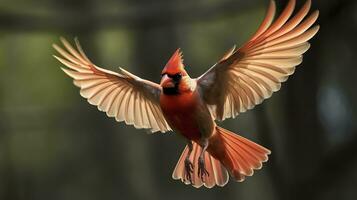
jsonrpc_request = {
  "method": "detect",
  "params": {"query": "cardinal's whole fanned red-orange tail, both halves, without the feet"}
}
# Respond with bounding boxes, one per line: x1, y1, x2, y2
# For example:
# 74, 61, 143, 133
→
172, 126, 270, 188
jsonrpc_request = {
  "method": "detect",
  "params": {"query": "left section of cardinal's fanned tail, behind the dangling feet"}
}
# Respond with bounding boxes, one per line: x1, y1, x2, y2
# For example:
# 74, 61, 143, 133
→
172, 142, 229, 188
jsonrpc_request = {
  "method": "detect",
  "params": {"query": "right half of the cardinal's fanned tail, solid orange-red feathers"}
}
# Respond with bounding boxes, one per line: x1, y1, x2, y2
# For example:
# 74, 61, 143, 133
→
217, 127, 270, 182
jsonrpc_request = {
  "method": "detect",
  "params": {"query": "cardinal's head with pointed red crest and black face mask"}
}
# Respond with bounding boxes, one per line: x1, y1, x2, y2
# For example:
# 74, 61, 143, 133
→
160, 49, 187, 94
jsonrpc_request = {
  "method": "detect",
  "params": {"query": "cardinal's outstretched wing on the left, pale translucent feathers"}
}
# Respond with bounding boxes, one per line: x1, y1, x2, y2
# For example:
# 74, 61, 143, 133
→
53, 38, 171, 132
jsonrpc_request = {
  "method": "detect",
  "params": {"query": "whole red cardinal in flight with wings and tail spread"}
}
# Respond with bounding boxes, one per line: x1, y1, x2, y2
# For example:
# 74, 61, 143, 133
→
53, 0, 319, 188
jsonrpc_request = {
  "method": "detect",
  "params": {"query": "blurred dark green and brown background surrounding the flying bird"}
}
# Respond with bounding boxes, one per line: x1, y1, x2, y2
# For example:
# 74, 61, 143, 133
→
0, 0, 357, 200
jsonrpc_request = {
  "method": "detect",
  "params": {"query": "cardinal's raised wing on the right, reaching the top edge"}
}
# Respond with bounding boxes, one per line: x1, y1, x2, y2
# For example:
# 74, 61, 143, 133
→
197, 0, 319, 120
